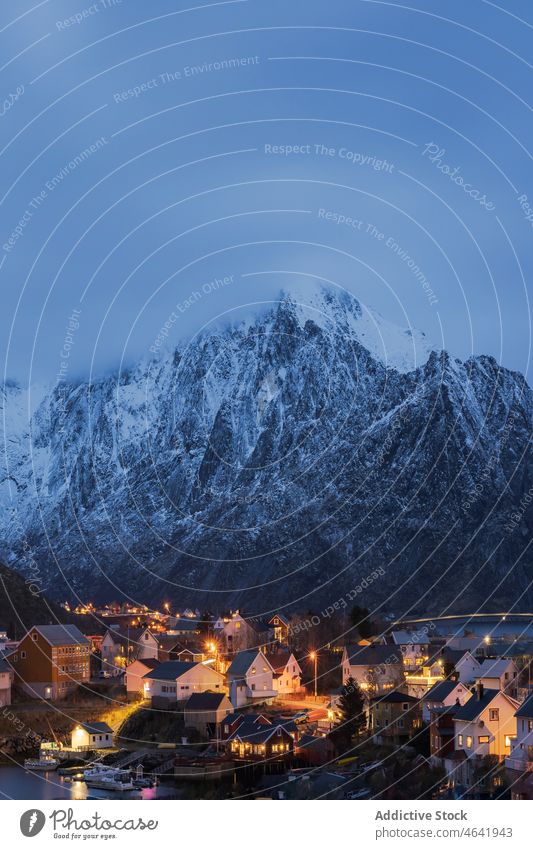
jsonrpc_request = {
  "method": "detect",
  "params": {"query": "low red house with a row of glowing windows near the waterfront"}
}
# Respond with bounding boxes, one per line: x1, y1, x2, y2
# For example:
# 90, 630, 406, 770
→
225, 714, 294, 762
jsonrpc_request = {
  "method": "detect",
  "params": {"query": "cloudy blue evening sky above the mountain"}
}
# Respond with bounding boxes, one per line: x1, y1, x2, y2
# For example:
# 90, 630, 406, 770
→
0, 0, 533, 384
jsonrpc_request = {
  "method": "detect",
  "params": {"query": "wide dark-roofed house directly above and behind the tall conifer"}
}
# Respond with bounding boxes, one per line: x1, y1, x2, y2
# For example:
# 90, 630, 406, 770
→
342, 644, 404, 696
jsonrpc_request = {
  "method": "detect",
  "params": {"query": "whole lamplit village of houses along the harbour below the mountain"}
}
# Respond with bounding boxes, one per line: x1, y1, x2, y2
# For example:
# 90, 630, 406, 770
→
0, 603, 533, 800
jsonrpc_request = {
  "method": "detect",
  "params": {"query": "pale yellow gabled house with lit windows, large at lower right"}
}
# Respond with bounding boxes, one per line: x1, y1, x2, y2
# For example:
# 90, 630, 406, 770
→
444, 682, 519, 785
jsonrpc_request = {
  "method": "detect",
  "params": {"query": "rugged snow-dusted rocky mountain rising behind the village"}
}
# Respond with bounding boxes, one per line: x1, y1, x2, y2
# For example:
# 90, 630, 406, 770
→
0, 288, 533, 613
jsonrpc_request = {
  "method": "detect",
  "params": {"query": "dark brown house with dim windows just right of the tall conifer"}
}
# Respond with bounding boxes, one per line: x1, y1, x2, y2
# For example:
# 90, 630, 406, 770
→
368, 691, 422, 746
